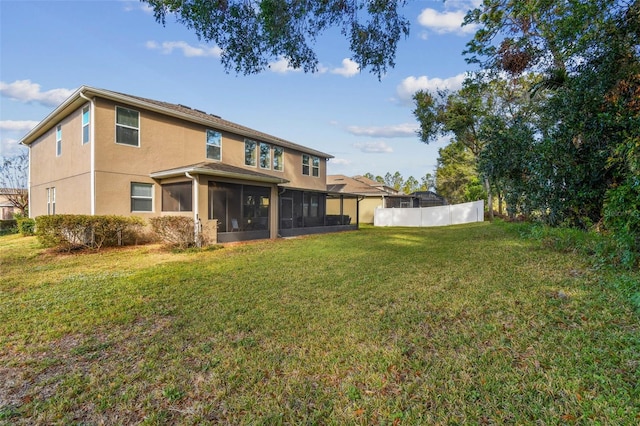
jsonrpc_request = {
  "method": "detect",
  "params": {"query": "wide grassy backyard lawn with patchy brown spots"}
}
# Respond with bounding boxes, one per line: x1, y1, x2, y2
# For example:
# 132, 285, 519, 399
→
0, 223, 640, 425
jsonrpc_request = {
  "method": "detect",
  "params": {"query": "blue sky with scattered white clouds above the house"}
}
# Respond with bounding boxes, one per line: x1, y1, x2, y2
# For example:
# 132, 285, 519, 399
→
0, 0, 478, 180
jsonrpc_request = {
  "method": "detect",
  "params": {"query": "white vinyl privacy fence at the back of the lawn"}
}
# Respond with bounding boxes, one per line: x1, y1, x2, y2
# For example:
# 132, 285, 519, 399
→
373, 200, 484, 226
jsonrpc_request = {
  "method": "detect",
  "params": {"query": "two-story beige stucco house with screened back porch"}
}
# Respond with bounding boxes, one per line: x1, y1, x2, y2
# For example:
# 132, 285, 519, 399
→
21, 86, 357, 242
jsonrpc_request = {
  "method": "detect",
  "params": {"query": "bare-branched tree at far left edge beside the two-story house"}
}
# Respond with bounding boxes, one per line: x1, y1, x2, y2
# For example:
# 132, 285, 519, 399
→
0, 152, 29, 215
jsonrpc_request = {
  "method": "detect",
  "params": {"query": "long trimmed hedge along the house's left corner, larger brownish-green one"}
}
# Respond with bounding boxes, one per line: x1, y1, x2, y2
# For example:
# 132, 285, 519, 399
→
36, 215, 144, 251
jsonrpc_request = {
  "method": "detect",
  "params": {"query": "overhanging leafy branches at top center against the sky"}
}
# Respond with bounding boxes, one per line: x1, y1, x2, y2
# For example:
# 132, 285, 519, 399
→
142, 0, 409, 78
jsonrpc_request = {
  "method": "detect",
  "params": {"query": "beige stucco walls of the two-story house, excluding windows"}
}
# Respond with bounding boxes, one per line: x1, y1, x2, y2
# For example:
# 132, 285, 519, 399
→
30, 95, 327, 243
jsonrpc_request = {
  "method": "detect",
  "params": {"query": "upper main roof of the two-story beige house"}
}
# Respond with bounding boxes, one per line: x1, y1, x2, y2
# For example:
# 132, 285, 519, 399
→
20, 86, 333, 158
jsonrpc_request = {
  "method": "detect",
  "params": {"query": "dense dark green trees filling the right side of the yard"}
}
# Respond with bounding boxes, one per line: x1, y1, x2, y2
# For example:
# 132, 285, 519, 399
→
414, 0, 640, 267
